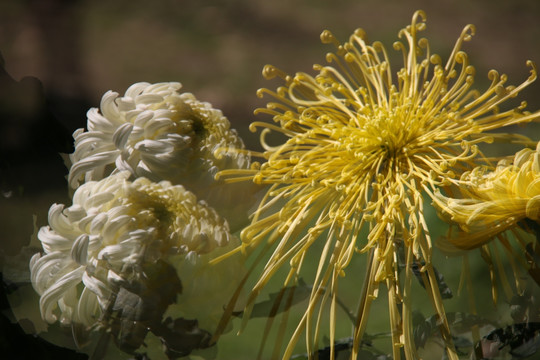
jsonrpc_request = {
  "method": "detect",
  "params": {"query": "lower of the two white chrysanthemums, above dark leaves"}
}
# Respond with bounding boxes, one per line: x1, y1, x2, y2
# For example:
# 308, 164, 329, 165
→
30, 172, 242, 332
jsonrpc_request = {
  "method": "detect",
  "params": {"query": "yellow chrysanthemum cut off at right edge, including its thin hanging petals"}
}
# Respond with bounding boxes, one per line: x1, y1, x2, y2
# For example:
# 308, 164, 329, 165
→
435, 143, 540, 301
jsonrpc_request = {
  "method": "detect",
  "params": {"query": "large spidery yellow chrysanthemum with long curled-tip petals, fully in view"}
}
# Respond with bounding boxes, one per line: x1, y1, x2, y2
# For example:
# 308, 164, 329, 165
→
216, 11, 539, 359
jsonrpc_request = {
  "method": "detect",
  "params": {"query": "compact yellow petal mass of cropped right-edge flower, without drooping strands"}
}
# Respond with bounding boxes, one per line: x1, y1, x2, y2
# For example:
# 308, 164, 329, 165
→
436, 142, 540, 249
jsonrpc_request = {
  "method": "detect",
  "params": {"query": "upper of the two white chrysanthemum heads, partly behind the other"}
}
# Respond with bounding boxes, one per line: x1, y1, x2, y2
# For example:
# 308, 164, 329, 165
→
69, 82, 250, 228
